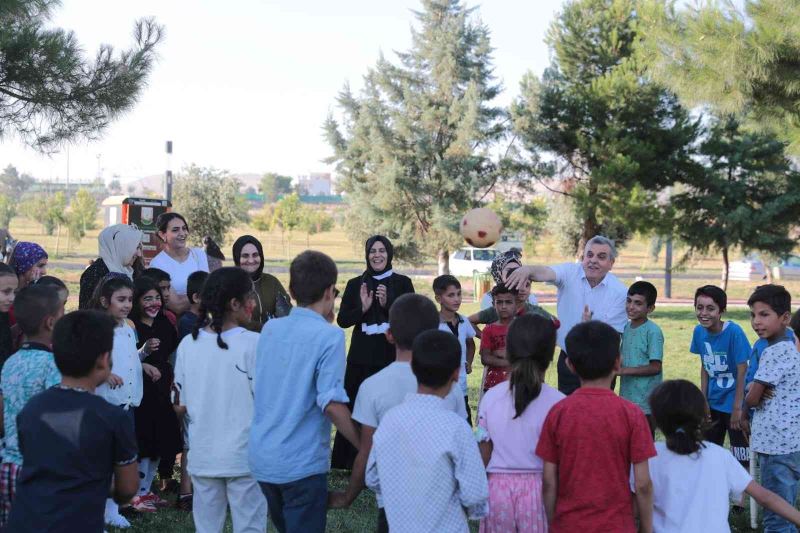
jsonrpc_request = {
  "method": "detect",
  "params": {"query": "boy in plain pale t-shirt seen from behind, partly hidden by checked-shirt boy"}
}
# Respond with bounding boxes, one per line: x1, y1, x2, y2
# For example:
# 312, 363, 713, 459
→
328, 294, 468, 533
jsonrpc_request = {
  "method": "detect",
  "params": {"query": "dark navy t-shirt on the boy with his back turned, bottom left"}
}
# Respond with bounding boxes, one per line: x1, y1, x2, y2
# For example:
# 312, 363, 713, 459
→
8, 387, 136, 533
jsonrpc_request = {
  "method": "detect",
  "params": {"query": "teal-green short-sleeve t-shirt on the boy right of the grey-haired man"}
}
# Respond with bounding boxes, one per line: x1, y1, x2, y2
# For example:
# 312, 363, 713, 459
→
619, 320, 664, 414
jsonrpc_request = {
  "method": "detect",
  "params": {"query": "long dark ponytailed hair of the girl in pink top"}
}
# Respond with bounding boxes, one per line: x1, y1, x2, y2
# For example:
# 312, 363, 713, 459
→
506, 315, 556, 418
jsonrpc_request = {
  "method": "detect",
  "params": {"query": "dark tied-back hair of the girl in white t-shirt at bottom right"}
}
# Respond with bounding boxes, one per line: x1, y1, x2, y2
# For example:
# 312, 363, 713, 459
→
650, 379, 708, 455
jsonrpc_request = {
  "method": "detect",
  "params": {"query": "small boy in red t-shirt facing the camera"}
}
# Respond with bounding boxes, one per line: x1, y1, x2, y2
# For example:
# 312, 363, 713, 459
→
480, 285, 519, 392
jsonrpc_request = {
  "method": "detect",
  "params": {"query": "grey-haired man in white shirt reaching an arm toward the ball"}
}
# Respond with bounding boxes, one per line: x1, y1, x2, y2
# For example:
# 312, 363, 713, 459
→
506, 235, 628, 394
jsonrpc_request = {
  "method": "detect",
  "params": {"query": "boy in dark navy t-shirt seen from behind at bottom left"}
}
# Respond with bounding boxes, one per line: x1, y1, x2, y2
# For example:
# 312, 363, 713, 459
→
7, 311, 139, 533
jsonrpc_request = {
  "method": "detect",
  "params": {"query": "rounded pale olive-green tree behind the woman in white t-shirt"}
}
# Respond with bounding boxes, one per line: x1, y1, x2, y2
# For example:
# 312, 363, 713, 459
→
173, 165, 248, 245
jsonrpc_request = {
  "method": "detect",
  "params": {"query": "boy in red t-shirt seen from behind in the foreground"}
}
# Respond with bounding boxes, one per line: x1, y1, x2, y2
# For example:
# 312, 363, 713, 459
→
536, 321, 656, 533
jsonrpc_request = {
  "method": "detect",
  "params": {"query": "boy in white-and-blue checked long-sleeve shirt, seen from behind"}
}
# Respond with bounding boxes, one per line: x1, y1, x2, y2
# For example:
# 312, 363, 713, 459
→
366, 330, 489, 533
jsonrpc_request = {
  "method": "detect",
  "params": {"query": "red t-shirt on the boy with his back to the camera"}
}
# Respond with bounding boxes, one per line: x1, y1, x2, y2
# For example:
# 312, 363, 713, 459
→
536, 387, 656, 533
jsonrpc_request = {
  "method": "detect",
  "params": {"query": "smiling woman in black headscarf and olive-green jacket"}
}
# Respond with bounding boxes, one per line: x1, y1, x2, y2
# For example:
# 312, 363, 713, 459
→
233, 235, 292, 332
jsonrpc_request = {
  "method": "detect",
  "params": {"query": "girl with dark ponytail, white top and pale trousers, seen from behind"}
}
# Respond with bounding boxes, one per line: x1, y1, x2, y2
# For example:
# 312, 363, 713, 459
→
175, 267, 267, 531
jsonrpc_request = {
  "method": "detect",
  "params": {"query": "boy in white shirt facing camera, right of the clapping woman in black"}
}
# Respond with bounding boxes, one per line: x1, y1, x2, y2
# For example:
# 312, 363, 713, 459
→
433, 274, 475, 426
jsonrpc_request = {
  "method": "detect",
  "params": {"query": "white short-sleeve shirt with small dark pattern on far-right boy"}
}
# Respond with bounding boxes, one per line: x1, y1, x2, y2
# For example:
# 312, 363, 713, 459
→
750, 340, 800, 455
